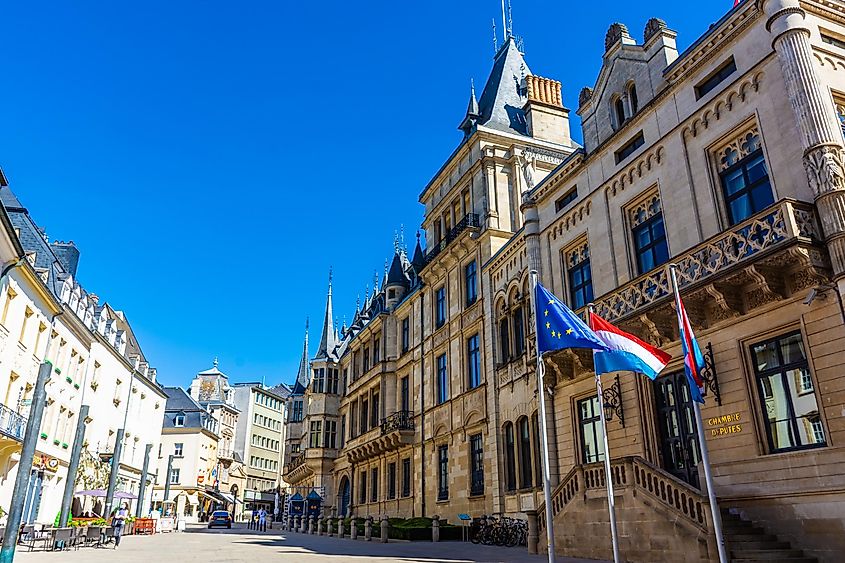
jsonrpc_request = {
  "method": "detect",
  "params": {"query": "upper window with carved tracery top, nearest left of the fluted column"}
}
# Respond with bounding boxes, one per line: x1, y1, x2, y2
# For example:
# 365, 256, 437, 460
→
719, 131, 774, 225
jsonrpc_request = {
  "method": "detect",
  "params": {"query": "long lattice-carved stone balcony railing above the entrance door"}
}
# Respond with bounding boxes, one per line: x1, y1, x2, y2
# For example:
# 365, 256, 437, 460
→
595, 200, 822, 321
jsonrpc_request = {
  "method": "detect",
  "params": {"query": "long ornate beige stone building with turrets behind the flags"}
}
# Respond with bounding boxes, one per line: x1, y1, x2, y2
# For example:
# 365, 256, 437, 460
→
286, 0, 845, 561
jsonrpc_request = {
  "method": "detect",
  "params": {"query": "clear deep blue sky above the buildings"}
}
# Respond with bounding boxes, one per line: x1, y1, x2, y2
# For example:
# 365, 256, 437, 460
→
0, 0, 733, 385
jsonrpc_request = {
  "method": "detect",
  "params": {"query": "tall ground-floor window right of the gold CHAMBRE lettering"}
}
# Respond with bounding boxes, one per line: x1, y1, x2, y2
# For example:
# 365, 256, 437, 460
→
751, 332, 827, 453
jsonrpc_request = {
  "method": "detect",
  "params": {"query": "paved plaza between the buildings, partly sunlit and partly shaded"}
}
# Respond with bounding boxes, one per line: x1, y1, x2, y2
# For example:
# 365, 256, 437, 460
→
15, 526, 608, 563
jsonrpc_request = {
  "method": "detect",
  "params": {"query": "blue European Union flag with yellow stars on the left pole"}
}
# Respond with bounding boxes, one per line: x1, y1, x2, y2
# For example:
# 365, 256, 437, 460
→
534, 283, 607, 354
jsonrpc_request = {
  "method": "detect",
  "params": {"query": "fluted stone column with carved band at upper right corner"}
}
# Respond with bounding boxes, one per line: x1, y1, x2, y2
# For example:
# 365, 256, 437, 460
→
757, 0, 845, 279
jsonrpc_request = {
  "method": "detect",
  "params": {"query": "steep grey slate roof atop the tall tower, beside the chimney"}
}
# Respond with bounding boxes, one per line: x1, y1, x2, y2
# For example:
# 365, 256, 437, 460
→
470, 37, 531, 135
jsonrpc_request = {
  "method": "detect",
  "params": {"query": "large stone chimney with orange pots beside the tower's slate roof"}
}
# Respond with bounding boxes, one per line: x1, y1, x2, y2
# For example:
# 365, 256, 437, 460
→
523, 74, 572, 146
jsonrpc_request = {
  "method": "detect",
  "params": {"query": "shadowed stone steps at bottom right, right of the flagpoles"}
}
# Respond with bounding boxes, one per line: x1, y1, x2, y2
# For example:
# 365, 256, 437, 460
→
721, 508, 818, 563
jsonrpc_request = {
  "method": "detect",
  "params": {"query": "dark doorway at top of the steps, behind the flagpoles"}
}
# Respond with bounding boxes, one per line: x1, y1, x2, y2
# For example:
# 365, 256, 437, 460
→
654, 371, 701, 489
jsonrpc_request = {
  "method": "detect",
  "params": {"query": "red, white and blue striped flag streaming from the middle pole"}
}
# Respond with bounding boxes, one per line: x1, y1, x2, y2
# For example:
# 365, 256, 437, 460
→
590, 313, 672, 379
